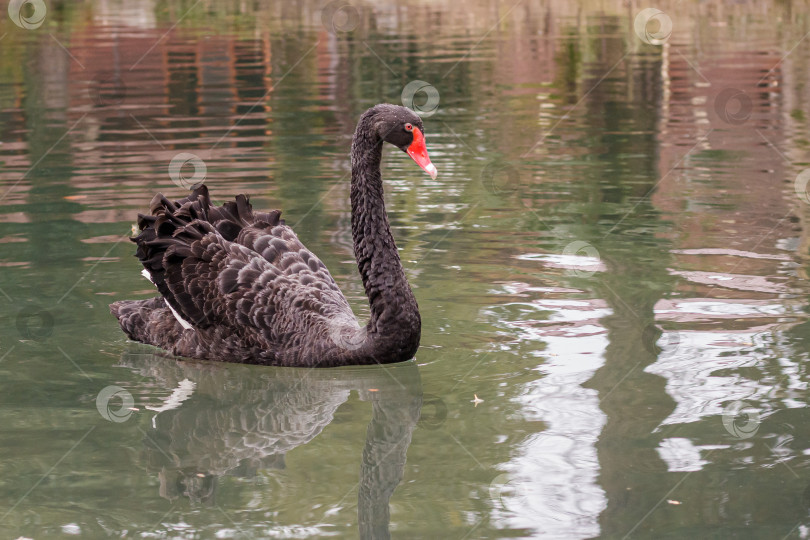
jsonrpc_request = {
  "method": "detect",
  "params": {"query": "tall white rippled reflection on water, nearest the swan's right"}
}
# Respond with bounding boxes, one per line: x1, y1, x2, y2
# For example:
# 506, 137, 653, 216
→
486, 292, 610, 538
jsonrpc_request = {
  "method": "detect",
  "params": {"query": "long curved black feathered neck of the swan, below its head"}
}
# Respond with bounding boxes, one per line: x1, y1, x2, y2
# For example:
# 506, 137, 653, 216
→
351, 120, 421, 354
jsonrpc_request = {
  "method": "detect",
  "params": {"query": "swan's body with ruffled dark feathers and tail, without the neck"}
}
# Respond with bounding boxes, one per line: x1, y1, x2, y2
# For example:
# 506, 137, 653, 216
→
111, 186, 359, 366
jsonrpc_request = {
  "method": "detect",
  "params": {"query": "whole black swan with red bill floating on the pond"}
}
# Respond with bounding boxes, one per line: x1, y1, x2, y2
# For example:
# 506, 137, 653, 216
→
110, 104, 437, 367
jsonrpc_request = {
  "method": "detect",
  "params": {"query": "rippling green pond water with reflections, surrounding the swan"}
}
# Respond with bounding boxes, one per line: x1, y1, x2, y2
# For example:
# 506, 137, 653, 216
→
0, 0, 810, 539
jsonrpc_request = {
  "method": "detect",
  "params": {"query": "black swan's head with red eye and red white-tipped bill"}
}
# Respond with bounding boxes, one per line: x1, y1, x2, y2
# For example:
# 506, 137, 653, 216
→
368, 104, 439, 179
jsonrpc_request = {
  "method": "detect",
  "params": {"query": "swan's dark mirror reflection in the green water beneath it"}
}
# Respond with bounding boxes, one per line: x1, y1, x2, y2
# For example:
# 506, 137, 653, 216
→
121, 351, 422, 539
